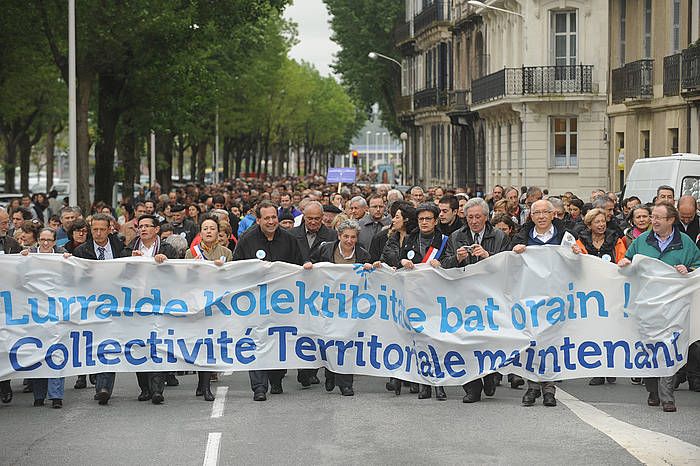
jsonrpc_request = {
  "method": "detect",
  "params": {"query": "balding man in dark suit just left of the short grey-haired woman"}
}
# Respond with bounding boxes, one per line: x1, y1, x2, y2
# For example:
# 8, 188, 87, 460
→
290, 201, 338, 388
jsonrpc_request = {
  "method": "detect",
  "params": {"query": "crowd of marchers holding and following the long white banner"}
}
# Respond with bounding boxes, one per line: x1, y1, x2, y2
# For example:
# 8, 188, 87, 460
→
0, 176, 700, 412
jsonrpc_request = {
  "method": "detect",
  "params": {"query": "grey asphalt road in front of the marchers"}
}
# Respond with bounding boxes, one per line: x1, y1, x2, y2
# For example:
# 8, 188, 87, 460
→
0, 371, 700, 466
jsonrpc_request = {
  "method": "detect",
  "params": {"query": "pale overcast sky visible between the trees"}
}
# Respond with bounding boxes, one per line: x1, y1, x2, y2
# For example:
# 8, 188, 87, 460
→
284, 0, 338, 76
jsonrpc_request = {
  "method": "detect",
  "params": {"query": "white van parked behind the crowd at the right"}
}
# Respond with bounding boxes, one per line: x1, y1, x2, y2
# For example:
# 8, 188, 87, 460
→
622, 154, 700, 203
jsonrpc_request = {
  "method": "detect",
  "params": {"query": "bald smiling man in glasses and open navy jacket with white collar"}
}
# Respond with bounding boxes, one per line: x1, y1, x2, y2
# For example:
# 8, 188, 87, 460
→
511, 200, 566, 406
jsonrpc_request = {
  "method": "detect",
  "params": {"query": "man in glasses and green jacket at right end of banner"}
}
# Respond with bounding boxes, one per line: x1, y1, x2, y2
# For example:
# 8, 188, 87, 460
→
617, 202, 700, 413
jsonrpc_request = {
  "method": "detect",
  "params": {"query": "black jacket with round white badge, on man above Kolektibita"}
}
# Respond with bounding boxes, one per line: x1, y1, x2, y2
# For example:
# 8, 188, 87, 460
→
233, 224, 307, 265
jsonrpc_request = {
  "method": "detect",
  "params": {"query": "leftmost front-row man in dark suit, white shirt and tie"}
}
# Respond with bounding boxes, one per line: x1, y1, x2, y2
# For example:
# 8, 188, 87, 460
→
73, 214, 131, 405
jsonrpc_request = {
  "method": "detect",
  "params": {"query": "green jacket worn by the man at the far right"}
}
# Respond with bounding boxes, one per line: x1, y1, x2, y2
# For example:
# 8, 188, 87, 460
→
625, 227, 700, 270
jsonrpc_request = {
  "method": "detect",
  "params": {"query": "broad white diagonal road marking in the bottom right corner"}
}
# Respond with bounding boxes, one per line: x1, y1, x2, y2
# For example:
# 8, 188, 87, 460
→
557, 387, 700, 465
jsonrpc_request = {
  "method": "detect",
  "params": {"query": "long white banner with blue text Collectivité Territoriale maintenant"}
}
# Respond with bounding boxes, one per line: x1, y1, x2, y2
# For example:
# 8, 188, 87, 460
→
0, 246, 700, 385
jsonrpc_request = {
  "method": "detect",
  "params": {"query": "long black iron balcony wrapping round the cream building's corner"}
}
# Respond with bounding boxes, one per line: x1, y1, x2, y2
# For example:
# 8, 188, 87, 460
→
472, 65, 593, 105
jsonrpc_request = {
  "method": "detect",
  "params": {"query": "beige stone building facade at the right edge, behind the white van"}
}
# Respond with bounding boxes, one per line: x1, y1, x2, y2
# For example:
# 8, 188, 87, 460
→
608, 0, 700, 190
